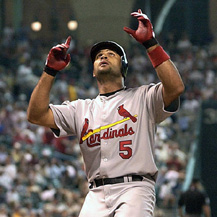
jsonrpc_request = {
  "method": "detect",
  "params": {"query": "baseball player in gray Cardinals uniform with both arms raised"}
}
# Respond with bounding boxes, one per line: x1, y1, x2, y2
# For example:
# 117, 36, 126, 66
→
28, 10, 184, 217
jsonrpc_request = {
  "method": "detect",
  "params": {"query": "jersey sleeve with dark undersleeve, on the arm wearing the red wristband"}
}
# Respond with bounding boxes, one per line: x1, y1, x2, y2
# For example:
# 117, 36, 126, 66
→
146, 82, 180, 123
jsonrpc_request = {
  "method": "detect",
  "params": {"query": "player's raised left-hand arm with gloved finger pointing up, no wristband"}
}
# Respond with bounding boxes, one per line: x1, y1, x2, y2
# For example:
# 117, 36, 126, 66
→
27, 37, 71, 129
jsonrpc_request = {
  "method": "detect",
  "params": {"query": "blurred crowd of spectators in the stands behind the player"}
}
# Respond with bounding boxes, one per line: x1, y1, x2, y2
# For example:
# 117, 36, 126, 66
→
0, 23, 217, 217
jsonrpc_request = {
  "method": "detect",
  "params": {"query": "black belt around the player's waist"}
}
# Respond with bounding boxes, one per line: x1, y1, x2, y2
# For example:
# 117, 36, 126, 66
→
89, 175, 153, 189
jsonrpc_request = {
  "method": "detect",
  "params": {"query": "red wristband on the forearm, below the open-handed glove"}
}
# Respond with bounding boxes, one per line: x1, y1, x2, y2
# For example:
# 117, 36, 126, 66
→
148, 46, 170, 68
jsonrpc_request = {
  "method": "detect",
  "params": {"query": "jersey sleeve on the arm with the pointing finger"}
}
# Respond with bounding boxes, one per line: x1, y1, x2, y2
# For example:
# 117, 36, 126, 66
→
49, 101, 76, 137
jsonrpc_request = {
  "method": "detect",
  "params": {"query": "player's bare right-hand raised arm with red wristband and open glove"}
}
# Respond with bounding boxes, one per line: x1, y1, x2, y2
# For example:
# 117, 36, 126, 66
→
124, 9, 184, 107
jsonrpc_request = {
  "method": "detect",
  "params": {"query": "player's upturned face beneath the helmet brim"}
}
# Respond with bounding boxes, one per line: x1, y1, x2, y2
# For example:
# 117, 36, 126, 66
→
93, 49, 122, 78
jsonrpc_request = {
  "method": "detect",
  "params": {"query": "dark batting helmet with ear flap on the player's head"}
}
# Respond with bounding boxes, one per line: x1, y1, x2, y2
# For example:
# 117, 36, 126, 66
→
90, 41, 128, 78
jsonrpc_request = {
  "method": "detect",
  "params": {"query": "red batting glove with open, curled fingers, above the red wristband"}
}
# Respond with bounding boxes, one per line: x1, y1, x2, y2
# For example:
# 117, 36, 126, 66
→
124, 9, 158, 49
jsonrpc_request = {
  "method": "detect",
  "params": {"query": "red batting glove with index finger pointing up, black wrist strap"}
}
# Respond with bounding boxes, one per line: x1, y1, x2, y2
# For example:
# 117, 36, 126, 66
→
44, 36, 72, 76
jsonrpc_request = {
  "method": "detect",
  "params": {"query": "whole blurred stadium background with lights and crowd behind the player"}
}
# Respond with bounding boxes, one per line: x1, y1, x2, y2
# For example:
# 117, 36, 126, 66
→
0, 0, 217, 217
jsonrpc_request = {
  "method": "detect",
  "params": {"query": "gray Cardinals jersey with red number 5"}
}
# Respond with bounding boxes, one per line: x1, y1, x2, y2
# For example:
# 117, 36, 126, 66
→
50, 83, 178, 182
